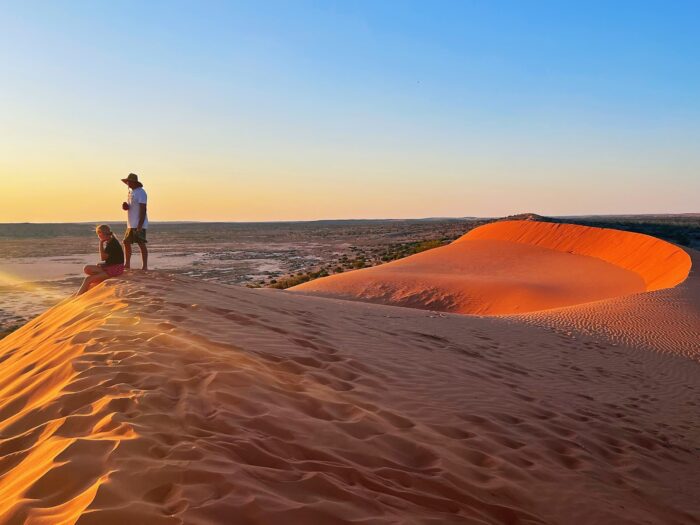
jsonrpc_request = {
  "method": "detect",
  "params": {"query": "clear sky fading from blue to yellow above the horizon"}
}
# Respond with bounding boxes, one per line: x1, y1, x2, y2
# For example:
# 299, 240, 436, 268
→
0, 0, 700, 222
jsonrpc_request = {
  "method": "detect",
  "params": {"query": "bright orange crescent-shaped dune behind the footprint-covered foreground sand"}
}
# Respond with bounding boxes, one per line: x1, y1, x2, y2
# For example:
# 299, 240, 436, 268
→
289, 221, 691, 315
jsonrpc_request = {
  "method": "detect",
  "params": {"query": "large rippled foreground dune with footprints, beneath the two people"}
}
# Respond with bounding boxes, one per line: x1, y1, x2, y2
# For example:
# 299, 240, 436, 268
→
0, 266, 700, 525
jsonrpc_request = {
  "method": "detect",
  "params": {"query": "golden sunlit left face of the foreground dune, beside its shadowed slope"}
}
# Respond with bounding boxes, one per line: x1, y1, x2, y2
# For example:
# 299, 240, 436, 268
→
0, 284, 136, 524
